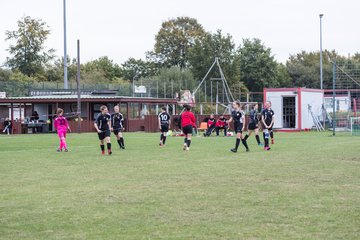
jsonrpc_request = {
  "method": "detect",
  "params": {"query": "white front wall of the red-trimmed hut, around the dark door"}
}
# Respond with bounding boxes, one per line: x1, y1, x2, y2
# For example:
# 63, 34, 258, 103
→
266, 91, 298, 128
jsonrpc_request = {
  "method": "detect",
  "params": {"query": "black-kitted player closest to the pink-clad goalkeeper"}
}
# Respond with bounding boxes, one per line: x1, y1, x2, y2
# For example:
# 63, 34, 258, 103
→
94, 105, 112, 155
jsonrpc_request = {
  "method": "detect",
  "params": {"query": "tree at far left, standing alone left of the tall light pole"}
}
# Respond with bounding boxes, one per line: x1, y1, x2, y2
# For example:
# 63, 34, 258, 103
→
5, 16, 54, 77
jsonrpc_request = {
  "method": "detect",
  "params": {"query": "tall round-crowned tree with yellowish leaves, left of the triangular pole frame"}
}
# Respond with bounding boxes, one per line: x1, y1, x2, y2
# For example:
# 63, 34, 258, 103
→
147, 17, 205, 68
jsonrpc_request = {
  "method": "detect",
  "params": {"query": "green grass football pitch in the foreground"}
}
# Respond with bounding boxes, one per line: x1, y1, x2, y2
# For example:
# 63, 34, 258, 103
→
0, 132, 360, 239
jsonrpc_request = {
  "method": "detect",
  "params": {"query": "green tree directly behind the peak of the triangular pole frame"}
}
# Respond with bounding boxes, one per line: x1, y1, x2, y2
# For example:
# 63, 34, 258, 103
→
189, 30, 240, 85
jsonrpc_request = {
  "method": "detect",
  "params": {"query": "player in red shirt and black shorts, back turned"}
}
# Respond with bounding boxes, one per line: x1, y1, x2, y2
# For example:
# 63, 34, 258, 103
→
181, 105, 196, 151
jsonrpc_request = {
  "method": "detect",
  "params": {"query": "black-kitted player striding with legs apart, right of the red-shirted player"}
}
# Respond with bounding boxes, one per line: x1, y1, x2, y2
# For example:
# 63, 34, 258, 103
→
229, 101, 249, 153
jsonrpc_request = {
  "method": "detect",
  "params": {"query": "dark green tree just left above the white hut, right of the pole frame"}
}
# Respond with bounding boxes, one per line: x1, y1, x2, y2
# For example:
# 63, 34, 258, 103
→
239, 38, 278, 92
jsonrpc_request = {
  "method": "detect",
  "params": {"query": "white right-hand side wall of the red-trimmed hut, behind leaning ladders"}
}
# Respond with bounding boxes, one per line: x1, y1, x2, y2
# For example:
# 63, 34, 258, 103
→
301, 89, 324, 129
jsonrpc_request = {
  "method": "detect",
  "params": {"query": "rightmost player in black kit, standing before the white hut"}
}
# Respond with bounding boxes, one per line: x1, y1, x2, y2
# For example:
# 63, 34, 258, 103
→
261, 102, 275, 151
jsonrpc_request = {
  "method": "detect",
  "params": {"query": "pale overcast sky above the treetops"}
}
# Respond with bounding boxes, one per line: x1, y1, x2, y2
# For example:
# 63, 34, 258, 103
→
0, 0, 360, 65
